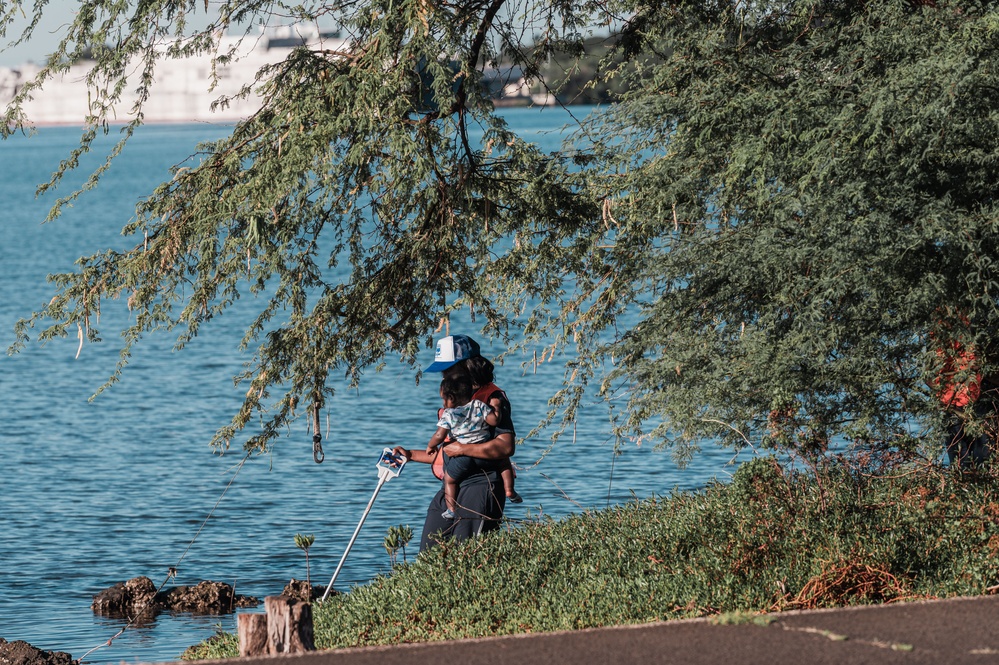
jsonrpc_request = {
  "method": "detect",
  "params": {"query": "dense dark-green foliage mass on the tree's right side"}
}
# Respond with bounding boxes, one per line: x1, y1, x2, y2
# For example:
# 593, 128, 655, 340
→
564, 0, 999, 455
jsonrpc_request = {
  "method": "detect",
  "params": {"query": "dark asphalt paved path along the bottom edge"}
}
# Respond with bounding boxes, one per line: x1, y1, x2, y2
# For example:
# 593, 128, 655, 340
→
203, 596, 999, 665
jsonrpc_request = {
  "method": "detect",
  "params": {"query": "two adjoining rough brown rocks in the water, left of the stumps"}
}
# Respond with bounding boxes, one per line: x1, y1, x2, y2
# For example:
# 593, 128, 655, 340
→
91, 577, 260, 616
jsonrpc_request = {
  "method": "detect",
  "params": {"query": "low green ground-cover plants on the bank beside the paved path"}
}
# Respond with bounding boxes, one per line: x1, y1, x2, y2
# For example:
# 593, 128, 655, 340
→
183, 457, 999, 660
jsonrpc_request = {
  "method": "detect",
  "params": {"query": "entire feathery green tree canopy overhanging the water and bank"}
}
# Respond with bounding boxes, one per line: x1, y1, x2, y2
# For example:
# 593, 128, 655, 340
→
0, 0, 999, 456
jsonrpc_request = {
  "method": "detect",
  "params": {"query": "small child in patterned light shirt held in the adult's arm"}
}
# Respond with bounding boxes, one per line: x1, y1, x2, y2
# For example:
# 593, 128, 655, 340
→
427, 376, 499, 519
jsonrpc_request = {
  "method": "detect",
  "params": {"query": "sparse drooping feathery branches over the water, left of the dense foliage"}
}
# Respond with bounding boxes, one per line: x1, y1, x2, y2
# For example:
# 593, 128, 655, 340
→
0, 0, 597, 450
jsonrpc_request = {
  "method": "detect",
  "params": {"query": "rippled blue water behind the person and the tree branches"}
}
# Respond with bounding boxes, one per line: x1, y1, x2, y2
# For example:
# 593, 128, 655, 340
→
0, 109, 744, 662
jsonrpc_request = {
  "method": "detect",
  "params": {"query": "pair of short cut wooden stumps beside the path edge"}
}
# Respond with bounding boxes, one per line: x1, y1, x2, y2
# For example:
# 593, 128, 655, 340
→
236, 596, 316, 657
